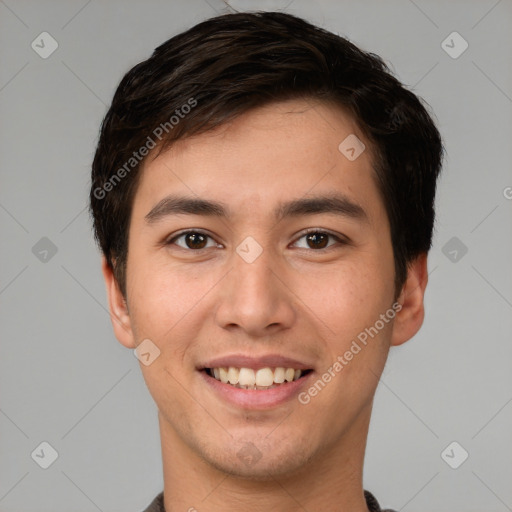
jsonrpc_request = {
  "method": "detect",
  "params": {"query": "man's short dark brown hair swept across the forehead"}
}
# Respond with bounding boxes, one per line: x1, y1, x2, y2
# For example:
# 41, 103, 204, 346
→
90, 12, 443, 297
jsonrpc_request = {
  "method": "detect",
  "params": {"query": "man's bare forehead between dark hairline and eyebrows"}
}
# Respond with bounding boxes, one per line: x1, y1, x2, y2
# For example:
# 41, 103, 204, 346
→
134, 100, 382, 228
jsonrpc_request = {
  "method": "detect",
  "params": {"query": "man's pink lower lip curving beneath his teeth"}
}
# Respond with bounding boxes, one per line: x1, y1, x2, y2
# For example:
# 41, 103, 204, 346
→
199, 371, 314, 410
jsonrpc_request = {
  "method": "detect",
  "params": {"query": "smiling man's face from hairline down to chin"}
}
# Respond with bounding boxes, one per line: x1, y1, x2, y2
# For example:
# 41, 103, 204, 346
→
103, 100, 421, 478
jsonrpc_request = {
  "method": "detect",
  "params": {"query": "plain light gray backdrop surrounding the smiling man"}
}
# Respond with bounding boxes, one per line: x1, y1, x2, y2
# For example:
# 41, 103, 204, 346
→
0, 0, 512, 512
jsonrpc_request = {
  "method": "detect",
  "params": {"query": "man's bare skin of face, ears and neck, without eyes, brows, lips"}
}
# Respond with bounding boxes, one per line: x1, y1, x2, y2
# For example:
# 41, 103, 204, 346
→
103, 100, 427, 512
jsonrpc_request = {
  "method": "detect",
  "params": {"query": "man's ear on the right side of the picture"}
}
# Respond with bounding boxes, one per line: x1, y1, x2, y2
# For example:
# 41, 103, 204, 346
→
391, 253, 428, 345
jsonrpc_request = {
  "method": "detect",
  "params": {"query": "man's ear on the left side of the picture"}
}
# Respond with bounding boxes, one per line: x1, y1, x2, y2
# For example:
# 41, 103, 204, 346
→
101, 256, 137, 348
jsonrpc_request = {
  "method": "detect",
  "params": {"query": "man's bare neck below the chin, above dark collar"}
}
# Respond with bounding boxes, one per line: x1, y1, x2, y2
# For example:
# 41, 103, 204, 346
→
159, 405, 371, 512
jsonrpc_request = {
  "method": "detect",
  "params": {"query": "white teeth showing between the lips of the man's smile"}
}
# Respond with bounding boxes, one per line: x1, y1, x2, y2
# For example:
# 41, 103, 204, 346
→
203, 366, 313, 390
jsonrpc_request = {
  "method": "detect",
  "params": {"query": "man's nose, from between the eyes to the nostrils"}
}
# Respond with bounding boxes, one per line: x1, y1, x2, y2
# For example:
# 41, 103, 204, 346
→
216, 243, 296, 337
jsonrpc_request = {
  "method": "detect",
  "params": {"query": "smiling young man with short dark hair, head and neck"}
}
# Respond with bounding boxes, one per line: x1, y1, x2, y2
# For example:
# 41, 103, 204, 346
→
90, 12, 443, 512
